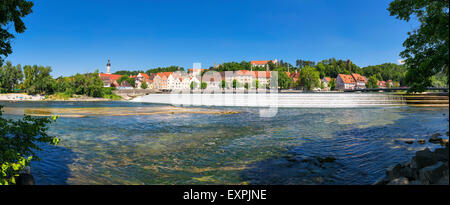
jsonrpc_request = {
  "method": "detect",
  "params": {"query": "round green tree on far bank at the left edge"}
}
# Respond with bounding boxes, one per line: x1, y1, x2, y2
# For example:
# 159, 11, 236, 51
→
0, 61, 23, 92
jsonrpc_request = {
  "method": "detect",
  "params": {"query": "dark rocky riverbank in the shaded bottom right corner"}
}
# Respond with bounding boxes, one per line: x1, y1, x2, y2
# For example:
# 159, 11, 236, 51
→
374, 141, 449, 185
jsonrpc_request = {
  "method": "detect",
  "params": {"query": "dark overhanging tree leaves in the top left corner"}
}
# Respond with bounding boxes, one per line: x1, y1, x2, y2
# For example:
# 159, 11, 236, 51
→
0, 0, 33, 66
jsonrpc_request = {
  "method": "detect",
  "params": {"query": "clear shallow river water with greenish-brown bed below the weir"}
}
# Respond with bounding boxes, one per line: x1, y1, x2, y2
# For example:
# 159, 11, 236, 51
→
0, 102, 449, 184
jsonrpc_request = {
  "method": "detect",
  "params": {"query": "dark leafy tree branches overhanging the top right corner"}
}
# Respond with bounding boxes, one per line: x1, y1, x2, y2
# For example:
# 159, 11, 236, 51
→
388, 0, 449, 92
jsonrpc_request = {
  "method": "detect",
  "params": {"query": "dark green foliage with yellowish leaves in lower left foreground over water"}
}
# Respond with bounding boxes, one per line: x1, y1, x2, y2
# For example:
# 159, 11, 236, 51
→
0, 106, 59, 185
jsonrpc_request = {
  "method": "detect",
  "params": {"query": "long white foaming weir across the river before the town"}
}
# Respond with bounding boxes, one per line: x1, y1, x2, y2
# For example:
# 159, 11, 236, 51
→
131, 93, 406, 108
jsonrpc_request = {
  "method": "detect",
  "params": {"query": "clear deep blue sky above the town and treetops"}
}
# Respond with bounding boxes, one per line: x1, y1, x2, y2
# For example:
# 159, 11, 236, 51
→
6, 0, 415, 76
